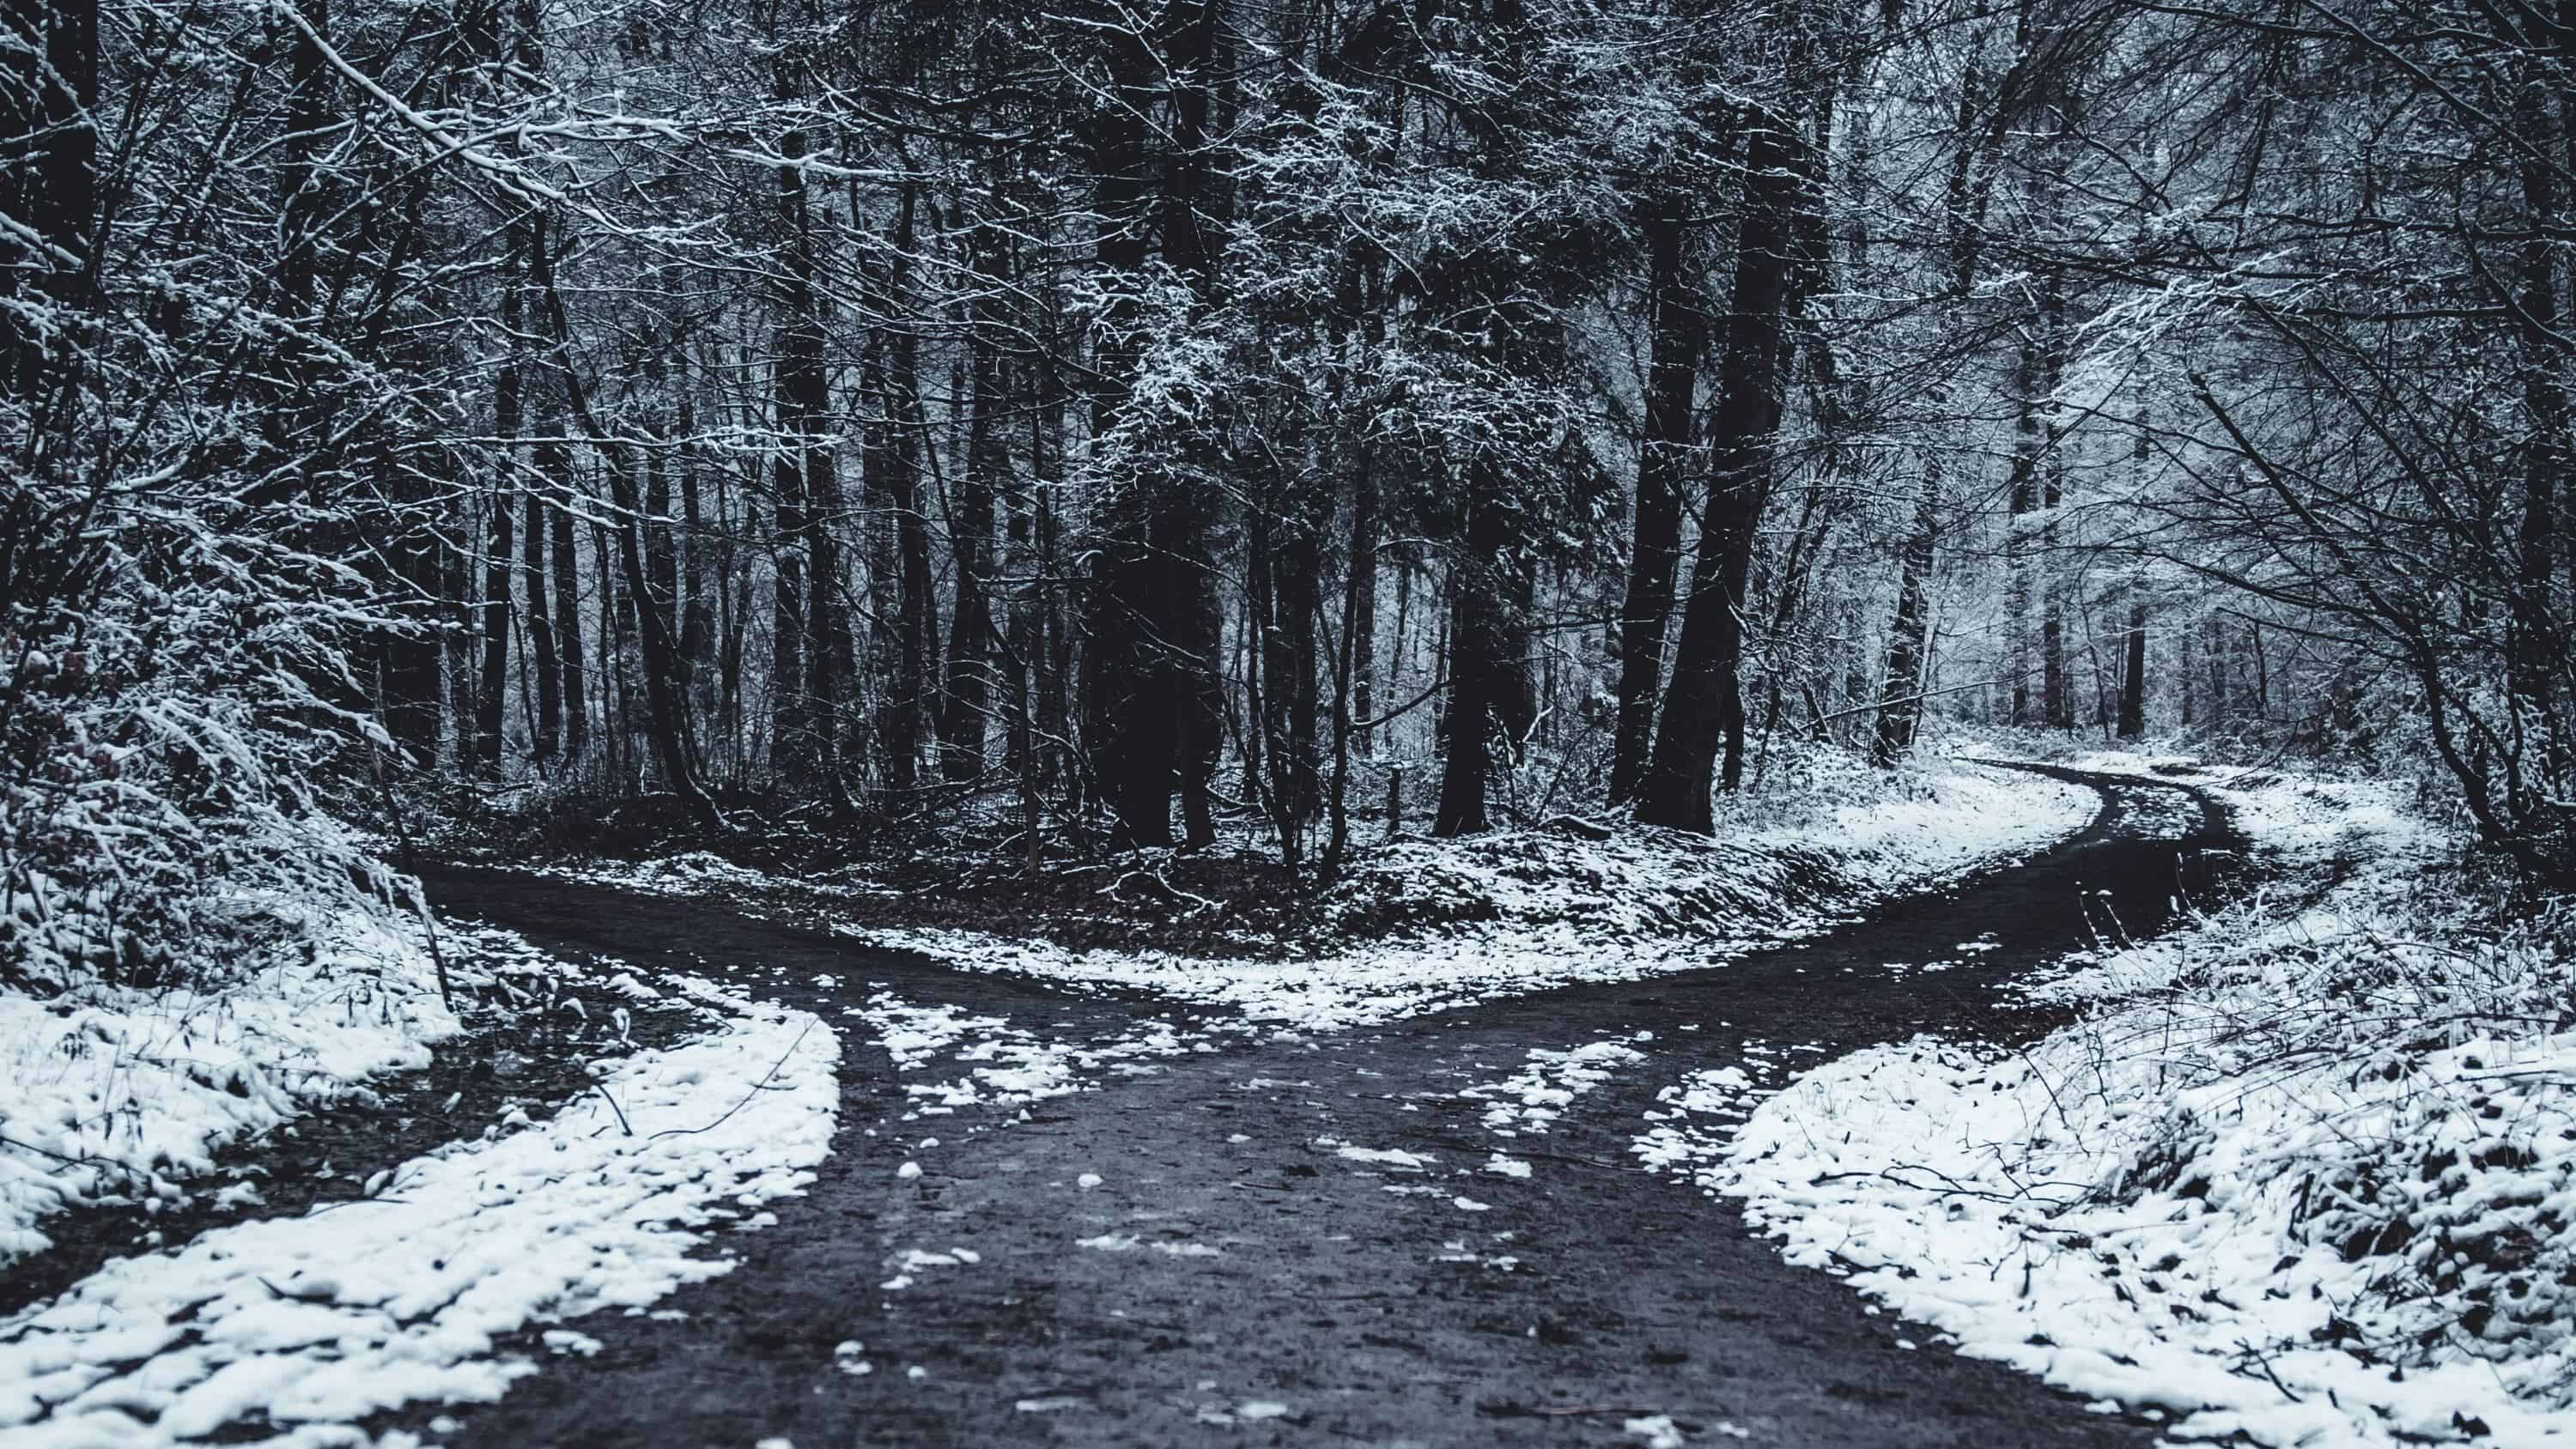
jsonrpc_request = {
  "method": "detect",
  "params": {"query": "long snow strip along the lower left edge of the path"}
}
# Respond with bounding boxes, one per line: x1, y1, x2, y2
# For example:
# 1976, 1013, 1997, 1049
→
0, 983, 840, 1449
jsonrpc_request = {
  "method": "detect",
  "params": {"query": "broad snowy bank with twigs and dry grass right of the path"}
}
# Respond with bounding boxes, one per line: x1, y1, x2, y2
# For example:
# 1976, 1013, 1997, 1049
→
1680, 759, 2576, 1446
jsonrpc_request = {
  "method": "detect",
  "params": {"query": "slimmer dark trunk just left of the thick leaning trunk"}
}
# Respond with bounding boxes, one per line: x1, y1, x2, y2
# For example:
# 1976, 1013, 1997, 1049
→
1610, 200, 1708, 805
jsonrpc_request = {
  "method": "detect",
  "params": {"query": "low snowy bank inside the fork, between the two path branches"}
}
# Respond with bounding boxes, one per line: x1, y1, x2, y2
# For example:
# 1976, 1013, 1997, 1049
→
845, 764, 2099, 1032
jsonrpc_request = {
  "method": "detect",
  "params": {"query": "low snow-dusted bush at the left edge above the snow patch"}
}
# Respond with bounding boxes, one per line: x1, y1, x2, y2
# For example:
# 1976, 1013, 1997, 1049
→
0, 573, 397, 991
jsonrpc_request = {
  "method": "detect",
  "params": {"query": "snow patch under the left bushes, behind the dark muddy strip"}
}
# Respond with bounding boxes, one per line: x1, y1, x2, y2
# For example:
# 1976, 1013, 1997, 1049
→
0, 913, 461, 1266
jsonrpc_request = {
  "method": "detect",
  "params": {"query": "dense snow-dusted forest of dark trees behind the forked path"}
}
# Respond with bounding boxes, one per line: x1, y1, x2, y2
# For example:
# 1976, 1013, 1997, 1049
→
0, 0, 2576, 975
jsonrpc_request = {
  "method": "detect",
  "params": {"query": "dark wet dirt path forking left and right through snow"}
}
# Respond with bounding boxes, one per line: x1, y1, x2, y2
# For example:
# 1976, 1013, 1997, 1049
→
407, 774, 2223, 1449
